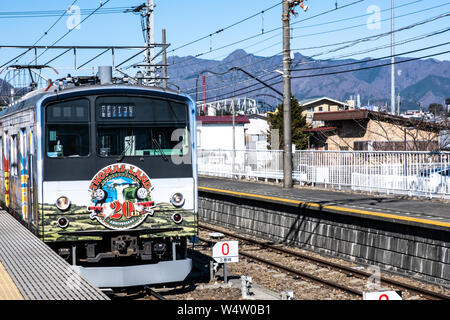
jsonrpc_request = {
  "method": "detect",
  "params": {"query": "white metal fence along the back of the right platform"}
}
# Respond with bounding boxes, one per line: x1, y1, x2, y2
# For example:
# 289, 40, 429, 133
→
198, 149, 450, 199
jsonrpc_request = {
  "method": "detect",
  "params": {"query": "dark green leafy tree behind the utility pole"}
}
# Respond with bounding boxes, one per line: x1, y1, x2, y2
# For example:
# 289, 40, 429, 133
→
267, 97, 310, 150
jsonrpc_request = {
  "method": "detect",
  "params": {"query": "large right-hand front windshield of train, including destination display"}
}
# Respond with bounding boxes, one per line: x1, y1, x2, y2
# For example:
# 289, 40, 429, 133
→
96, 96, 189, 157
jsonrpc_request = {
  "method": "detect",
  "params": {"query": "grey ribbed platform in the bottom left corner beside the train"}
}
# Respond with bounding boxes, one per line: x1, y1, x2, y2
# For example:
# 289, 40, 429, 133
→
0, 210, 109, 300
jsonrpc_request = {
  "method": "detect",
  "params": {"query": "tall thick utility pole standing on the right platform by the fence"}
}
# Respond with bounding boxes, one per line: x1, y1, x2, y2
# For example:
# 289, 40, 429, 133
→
282, 0, 292, 188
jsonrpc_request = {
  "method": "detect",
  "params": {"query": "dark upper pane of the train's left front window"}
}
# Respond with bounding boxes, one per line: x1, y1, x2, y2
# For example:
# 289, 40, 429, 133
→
46, 99, 89, 123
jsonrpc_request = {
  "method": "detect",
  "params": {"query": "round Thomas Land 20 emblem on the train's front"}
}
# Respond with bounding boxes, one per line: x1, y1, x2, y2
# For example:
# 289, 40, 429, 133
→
88, 163, 155, 230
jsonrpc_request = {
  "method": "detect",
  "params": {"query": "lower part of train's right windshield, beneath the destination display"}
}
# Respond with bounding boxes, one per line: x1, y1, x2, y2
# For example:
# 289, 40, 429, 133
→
97, 125, 189, 157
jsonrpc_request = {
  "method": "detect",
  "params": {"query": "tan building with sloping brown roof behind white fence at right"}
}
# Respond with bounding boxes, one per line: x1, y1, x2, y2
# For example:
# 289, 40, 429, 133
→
306, 109, 449, 151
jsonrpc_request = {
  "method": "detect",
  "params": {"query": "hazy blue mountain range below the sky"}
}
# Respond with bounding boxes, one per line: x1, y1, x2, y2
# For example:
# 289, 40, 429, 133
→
168, 49, 450, 109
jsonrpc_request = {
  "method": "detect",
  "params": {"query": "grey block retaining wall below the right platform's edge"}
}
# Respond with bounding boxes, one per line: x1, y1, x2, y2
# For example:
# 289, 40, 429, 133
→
199, 192, 450, 287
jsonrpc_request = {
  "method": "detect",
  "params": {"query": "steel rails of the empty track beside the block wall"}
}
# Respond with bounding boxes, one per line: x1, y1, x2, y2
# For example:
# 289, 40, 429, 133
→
199, 223, 450, 300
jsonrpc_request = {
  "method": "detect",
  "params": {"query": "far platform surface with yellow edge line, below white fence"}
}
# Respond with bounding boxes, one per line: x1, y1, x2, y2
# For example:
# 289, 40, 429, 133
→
198, 176, 450, 231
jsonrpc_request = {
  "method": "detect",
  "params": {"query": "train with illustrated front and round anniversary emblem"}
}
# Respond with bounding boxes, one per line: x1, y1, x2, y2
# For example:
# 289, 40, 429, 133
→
0, 67, 198, 288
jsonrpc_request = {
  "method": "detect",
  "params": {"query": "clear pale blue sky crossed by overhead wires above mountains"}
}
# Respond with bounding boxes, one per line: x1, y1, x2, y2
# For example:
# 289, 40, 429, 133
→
0, 0, 450, 82
